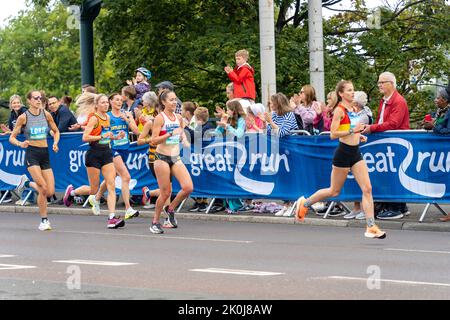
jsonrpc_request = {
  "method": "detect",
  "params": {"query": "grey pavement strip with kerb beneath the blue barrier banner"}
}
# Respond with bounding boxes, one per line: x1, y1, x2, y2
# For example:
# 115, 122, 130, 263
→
0, 199, 450, 232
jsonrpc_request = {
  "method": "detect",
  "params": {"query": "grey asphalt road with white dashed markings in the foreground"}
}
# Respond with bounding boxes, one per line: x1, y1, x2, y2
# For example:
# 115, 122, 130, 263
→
0, 212, 450, 300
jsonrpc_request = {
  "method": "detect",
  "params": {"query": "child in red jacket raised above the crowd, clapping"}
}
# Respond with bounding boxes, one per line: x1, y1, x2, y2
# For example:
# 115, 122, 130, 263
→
224, 50, 256, 102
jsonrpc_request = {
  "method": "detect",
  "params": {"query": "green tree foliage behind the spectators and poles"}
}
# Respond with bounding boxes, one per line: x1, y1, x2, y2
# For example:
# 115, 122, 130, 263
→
0, 0, 450, 123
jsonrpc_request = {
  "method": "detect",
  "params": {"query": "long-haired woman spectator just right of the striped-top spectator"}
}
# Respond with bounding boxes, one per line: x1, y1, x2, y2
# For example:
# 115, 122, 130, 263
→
291, 84, 321, 134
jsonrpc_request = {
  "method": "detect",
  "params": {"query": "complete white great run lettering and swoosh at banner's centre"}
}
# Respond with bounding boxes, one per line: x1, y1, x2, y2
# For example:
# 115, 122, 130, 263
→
188, 141, 290, 196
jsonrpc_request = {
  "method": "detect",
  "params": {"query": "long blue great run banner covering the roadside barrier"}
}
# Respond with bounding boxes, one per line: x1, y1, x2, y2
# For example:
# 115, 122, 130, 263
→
0, 131, 450, 203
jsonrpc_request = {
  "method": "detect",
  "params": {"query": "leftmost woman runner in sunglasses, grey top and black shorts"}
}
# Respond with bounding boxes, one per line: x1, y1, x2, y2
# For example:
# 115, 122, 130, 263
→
9, 90, 60, 231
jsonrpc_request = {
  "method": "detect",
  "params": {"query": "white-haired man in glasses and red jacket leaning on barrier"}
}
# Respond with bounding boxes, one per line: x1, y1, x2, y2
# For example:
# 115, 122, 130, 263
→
362, 72, 410, 220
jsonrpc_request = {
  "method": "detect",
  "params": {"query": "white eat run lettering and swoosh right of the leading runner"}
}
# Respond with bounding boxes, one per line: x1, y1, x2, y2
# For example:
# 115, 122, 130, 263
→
351, 138, 450, 198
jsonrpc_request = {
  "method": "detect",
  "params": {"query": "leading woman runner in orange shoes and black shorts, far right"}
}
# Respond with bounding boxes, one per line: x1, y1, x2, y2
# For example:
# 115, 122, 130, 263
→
295, 80, 386, 239
